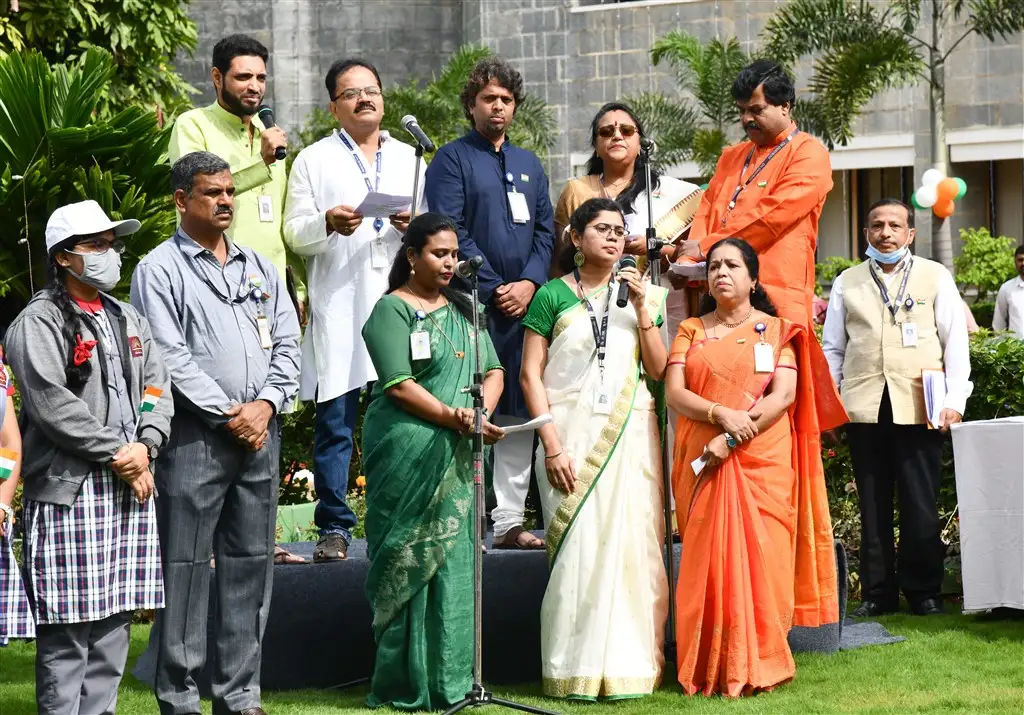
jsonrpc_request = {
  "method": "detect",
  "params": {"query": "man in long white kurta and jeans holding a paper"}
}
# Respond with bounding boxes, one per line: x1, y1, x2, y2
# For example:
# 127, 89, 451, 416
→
284, 59, 425, 561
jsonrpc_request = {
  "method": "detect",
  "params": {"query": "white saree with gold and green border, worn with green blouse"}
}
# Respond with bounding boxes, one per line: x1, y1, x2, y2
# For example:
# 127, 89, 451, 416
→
536, 285, 669, 700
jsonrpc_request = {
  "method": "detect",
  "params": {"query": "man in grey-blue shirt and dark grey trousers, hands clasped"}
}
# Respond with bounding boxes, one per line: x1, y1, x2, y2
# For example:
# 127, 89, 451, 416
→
131, 152, 299, 715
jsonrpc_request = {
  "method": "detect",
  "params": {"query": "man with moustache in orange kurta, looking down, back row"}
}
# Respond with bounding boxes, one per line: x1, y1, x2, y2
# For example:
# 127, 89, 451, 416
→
683, 59, 833, 327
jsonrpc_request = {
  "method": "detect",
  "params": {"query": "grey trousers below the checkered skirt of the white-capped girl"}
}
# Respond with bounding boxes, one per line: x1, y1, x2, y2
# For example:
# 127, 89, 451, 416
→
35, 611, 132, 715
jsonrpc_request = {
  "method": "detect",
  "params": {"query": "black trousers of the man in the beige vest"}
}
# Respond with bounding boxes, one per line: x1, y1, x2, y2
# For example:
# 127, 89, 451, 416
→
847, 390, 945, 607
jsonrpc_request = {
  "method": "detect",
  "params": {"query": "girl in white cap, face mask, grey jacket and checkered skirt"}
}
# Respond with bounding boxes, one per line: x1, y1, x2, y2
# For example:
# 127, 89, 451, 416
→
7, 201, 173, 715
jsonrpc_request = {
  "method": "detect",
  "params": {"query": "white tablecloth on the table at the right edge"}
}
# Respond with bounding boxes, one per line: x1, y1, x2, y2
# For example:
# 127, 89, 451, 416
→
952, 417, 1024, 611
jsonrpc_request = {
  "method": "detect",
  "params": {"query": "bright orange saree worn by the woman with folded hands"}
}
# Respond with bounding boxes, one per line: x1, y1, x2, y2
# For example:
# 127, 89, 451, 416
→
670, 319, 845, 697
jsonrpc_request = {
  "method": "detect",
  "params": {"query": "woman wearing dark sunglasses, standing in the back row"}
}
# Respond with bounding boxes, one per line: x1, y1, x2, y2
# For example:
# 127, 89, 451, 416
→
551, 101, 700, 280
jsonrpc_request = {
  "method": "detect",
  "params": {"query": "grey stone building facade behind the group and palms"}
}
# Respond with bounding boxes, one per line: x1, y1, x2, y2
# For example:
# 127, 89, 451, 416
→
179, 0, 1024, 256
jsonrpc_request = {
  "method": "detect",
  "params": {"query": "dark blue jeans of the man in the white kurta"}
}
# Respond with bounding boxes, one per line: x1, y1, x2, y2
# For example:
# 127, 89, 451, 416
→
313, 388, 359, 542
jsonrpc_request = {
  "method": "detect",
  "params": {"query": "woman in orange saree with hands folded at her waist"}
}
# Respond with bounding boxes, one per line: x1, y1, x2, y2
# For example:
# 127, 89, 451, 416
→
666, 239, 845, 697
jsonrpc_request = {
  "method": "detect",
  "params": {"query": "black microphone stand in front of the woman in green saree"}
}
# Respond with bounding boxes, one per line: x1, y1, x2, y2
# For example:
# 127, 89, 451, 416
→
444, 272, 558, 715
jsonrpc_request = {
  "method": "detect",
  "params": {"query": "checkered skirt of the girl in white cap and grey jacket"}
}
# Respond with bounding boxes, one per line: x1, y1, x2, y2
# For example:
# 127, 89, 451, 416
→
25, 467, 164, 624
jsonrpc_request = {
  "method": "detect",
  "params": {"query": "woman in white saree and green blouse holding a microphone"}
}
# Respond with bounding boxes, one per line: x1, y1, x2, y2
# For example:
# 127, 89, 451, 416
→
521, 199, 669, 701
